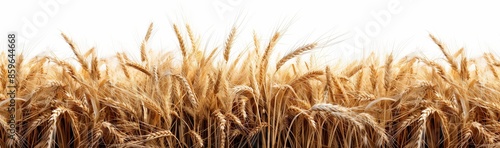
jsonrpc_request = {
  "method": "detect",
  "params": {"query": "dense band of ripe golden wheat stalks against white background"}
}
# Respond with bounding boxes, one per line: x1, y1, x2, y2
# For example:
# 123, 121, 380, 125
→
0, 24, 500, 148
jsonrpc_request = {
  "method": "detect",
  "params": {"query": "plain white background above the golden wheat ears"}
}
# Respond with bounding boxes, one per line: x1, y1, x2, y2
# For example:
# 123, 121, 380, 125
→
0, 0, 500, 64
